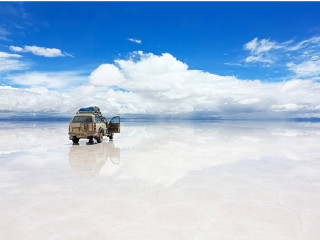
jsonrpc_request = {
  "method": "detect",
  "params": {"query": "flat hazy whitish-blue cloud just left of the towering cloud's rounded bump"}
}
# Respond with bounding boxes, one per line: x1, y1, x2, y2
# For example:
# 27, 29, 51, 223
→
6, 71, 87, 89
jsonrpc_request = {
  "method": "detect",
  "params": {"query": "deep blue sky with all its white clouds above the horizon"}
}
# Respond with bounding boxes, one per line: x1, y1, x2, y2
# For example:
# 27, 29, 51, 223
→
0, 2, 320, 119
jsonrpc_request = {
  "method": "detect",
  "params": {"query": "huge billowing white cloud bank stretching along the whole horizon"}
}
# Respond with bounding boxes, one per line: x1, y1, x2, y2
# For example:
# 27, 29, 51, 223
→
0, 52, 320, 118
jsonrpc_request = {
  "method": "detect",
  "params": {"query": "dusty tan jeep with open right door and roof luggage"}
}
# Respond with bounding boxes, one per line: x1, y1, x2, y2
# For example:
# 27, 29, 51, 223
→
69, 107, 120, 143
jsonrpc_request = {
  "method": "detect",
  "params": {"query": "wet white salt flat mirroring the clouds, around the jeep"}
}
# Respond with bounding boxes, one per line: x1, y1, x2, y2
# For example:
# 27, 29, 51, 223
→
0, 121, 320, 240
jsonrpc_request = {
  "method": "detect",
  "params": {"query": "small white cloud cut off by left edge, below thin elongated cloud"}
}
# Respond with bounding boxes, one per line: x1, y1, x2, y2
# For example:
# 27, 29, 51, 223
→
0, 52, 28, 72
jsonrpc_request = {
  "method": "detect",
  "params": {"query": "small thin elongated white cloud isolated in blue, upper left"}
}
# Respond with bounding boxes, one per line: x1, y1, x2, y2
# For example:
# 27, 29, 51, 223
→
10, 46, 72, 57
